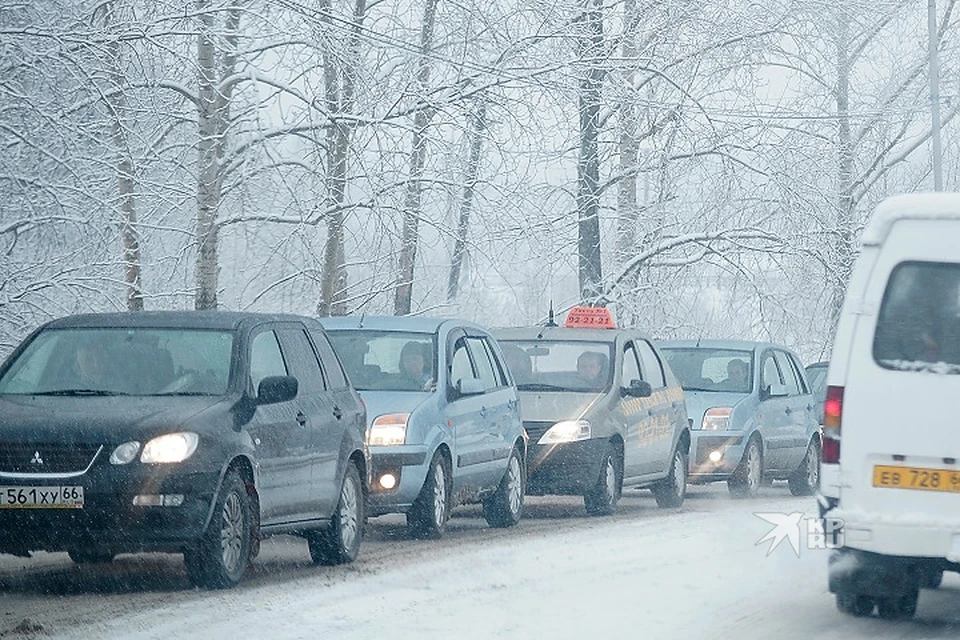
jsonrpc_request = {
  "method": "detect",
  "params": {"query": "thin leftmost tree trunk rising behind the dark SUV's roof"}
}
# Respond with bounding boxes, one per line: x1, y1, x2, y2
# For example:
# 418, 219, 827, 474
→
104, 2, 143, 311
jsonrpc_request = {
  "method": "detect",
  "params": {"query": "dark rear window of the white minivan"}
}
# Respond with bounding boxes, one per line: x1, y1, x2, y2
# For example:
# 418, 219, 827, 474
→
873, 261, 960, 374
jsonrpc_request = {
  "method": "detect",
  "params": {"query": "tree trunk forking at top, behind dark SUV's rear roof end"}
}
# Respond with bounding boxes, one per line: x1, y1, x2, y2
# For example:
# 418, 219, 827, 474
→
317, 0, 367, 316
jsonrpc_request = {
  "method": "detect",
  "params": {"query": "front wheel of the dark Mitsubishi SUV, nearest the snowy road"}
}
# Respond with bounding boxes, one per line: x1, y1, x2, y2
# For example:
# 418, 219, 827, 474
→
183, 471, 253, 589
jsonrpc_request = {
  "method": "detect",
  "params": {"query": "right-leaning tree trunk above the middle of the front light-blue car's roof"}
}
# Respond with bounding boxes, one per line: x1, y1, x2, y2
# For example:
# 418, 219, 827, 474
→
393, 0, 437, 316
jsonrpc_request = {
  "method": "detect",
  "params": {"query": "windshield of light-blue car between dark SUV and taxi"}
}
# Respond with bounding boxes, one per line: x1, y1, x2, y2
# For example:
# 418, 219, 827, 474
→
327, 329, 437, 391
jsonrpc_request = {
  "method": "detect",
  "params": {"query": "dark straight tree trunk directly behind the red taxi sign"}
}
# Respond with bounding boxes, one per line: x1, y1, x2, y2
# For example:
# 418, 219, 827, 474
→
577, 0, 603, 302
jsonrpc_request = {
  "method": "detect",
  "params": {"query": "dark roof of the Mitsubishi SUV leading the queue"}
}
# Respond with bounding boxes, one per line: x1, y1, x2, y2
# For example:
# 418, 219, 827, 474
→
44, 310, 316, 330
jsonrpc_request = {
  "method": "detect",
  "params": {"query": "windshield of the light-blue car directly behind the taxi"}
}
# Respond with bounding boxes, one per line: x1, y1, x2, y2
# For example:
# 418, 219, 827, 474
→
663, 347, 753, 393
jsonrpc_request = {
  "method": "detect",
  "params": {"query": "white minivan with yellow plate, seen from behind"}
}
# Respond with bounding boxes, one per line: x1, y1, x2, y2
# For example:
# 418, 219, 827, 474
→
820, 194, 960, 618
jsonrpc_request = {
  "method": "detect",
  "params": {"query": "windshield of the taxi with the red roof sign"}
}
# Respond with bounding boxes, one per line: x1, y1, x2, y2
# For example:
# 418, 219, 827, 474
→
500, 340, 613, 392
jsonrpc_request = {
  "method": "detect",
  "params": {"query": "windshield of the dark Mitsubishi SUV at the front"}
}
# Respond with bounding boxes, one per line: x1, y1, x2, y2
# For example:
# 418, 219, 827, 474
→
0, 328, 233, 395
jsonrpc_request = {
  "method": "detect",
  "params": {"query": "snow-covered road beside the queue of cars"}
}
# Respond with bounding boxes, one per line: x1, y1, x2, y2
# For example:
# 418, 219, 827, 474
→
0, 485, 960, 640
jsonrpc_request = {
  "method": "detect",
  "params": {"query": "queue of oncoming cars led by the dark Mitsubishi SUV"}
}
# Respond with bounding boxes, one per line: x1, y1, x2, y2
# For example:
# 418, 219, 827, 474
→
0, 307, 820, 588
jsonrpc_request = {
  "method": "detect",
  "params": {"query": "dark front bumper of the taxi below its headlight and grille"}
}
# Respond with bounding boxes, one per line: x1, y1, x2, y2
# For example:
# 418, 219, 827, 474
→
527, 438, 610, 495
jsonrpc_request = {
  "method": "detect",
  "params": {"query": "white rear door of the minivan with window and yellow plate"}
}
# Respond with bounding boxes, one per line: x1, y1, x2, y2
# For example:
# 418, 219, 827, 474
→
832, 219, 960, 515
